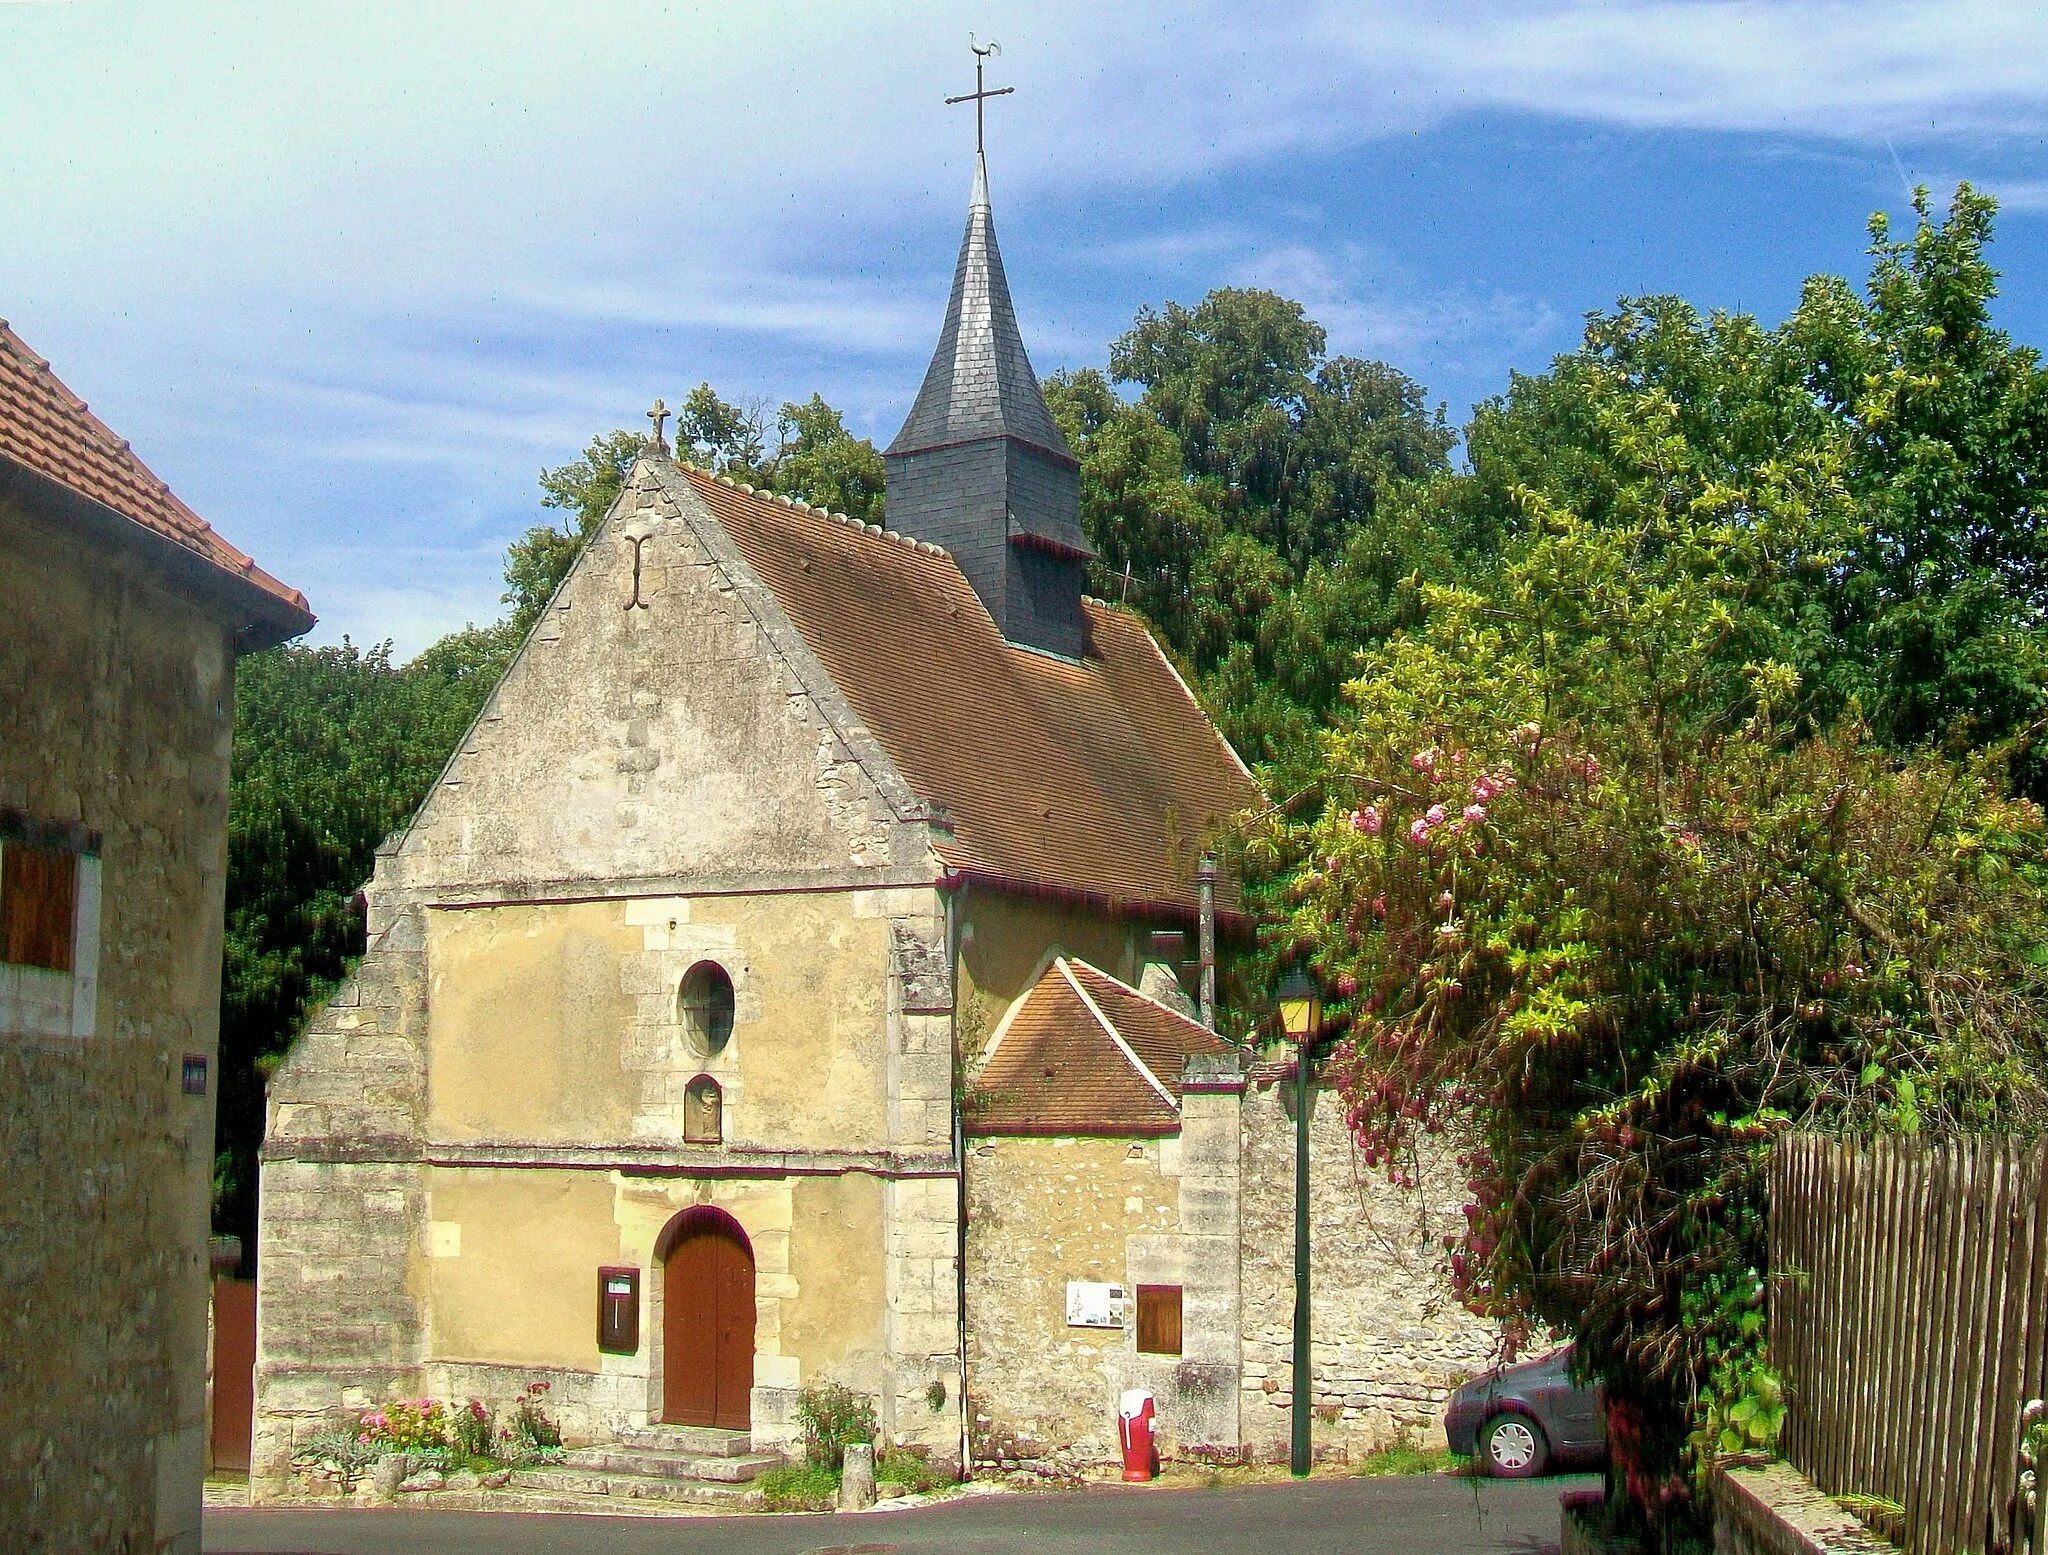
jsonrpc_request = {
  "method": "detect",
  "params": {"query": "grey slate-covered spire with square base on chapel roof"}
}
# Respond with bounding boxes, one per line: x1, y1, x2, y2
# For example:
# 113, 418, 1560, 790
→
883, 154, 1090, 658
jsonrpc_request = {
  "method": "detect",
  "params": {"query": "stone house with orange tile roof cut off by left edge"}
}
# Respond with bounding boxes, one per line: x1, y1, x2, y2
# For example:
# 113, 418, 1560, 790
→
0, 324, 313, 1553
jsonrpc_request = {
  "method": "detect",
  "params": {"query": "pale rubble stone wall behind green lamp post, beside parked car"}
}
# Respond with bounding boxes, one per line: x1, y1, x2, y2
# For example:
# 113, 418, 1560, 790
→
1243, 1080, 1495, 1459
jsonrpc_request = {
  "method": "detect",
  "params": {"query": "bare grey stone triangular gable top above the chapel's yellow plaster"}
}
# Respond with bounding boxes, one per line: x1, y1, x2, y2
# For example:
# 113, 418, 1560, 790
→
373, 459, 930, 903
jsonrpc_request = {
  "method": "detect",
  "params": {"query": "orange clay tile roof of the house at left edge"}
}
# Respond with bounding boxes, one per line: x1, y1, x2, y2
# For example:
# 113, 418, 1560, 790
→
0, 320, 313, 635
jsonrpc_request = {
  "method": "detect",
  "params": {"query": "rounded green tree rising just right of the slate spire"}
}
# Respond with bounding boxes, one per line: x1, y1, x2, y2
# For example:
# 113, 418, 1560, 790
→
1047, 289, 1464, 774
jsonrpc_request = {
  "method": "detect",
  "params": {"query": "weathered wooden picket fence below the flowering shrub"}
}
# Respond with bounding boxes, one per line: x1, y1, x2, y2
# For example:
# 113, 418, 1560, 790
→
1769, 1135, 2048, 1555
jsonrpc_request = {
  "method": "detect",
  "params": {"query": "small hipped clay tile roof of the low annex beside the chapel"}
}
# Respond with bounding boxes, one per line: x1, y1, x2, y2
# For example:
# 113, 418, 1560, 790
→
963, 957, 1229, 1137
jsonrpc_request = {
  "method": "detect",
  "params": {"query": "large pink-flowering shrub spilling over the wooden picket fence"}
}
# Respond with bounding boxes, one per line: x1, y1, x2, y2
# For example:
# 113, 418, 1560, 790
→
1247, 510, 2048, 1516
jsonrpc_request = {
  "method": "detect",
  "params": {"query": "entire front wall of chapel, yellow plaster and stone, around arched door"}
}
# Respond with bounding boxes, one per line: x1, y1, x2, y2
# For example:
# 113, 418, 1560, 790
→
254, 461, 958, 1496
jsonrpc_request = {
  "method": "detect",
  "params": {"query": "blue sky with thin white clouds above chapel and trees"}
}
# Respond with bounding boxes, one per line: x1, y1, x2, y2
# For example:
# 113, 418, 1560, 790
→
0, 0, 2048, 654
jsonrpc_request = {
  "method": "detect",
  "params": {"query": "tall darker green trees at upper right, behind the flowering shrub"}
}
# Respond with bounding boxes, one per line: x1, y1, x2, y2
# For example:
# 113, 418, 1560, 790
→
1444, 184, 2048, 783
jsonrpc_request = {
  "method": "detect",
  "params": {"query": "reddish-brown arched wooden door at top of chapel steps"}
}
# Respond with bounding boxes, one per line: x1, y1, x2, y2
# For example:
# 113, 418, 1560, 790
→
662, 1207, 754, 1430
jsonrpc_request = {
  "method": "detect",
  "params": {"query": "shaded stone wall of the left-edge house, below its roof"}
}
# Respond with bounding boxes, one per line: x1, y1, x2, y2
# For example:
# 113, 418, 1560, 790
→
0, 504, 233, 1555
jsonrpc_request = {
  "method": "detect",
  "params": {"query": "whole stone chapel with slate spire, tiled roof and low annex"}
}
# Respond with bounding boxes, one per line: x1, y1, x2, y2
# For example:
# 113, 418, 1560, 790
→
252, 148, 1487, 1498
